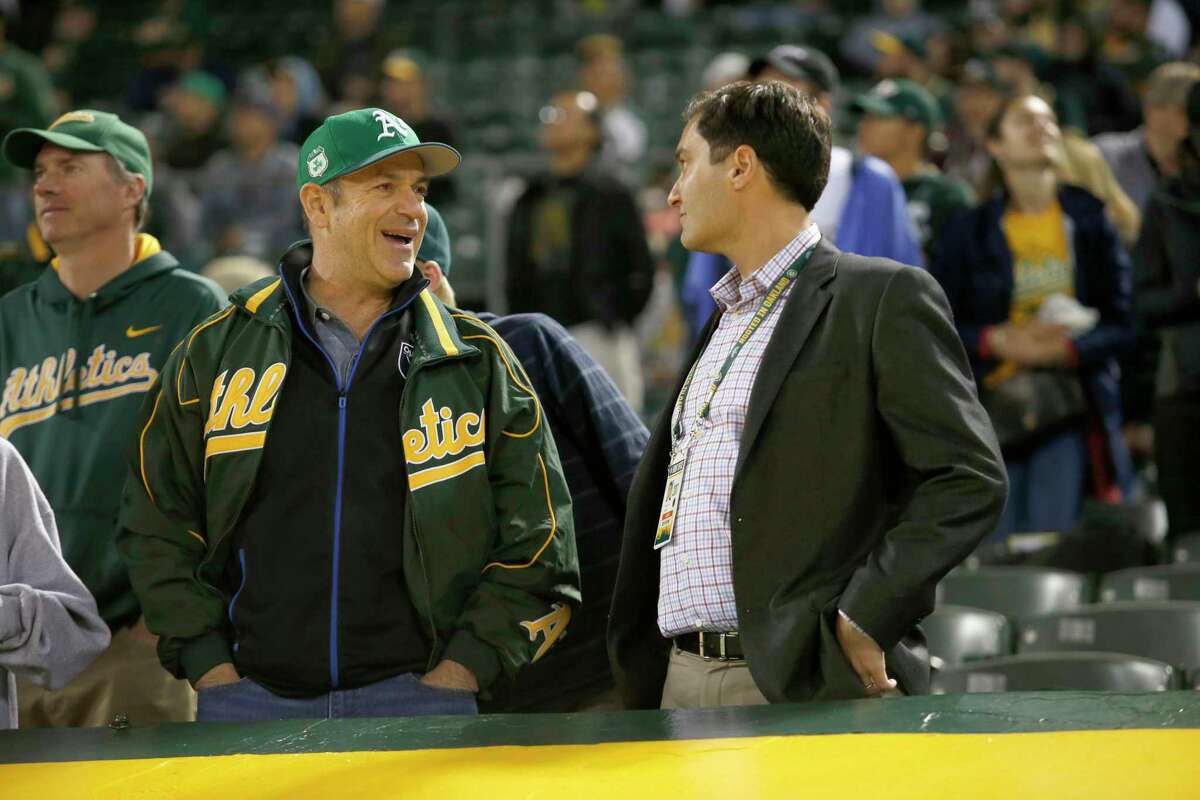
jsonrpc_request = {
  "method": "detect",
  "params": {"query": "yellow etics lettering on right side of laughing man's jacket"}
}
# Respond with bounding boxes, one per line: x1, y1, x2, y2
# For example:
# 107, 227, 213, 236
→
403, 398, 487, 492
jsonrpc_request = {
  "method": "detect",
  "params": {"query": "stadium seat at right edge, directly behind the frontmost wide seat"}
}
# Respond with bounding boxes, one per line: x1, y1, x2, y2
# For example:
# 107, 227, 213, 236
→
1016, 601, 1200, 669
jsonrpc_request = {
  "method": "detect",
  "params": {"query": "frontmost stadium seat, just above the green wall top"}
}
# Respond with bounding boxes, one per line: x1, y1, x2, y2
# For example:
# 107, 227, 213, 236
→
932, 652, 1183, 694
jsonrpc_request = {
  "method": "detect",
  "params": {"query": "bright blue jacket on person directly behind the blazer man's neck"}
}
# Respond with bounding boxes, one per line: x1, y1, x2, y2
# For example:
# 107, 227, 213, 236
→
680, 156, 925, 341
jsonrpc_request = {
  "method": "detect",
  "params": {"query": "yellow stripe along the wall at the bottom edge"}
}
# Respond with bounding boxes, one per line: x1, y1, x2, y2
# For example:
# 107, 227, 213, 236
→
0, 734, 1200, 800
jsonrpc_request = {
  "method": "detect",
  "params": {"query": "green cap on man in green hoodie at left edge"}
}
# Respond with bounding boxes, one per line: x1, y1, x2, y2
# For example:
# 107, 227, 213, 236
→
4, 108, 154, 197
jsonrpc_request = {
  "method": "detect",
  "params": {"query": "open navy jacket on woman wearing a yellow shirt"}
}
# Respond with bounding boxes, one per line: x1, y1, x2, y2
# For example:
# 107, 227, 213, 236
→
930, 186, 1134, 497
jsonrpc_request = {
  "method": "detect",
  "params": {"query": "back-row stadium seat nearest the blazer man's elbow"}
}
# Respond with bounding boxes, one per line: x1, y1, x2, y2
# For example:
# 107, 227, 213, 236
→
937, 566, 1088, 620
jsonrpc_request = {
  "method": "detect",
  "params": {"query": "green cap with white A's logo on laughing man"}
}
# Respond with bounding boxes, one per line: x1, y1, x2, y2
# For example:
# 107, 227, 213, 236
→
296, 108, 462, 190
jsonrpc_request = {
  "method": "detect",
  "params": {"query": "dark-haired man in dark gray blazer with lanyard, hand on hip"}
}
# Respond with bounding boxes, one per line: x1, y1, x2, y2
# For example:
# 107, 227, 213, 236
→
608, 82, 1007, 708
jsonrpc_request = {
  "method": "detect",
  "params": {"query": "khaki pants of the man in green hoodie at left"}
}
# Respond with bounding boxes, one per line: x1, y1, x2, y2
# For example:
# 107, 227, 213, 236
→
17, 627, 196, 728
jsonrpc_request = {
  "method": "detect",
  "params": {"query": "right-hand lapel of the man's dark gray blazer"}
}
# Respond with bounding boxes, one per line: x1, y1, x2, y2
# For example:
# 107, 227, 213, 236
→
733, 237, 841, 481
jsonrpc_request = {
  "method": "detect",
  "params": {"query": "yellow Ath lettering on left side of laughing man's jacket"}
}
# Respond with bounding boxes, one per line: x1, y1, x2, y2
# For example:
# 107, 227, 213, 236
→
204, 361, 288, 459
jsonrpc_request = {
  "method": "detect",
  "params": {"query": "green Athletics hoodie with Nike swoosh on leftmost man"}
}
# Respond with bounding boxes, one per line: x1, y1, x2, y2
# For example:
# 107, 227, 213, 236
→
0, 234, 224, 628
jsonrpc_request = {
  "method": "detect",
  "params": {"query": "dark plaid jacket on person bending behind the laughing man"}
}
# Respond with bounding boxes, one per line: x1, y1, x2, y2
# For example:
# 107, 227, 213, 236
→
479, 314, 650, 711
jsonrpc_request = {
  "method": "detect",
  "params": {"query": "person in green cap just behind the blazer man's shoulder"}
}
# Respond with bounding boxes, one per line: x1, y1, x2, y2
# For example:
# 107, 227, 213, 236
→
853, 79, 973, 264
